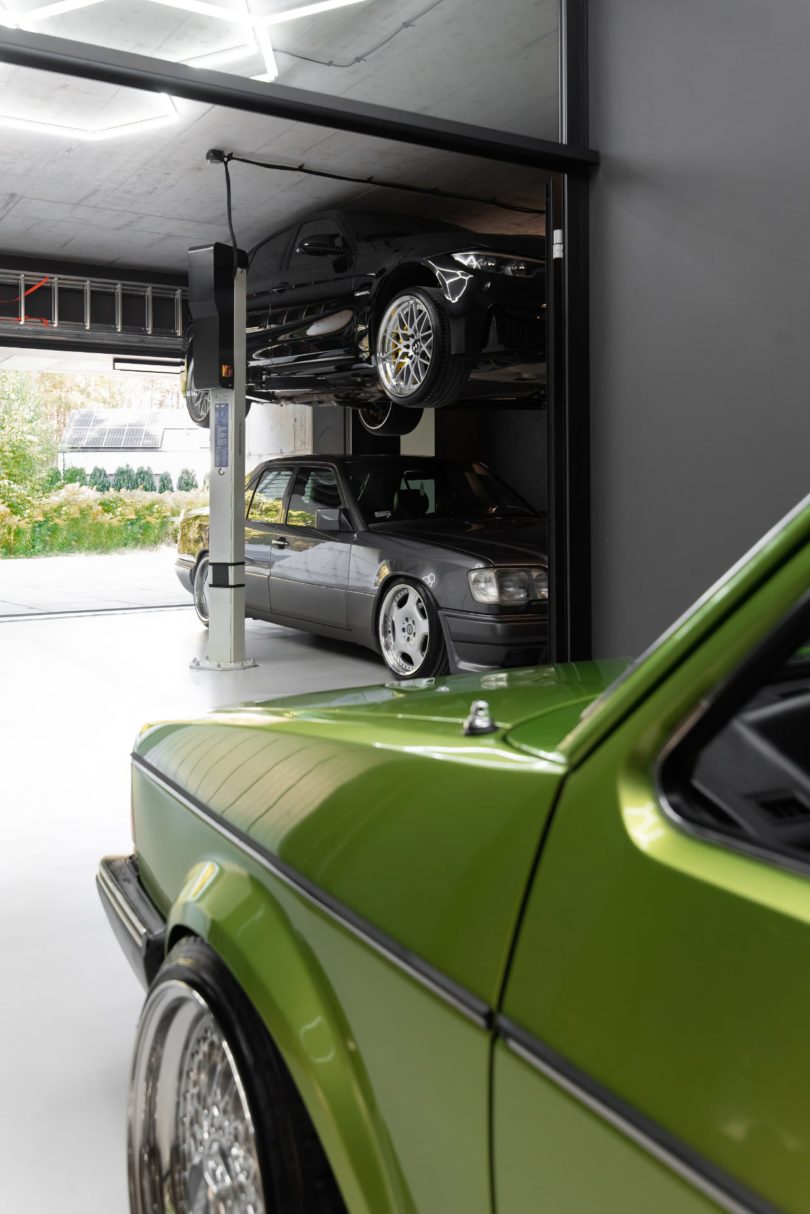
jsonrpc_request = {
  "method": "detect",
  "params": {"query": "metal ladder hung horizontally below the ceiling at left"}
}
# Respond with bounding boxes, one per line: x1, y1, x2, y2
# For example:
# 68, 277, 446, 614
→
0, 268, 188, 353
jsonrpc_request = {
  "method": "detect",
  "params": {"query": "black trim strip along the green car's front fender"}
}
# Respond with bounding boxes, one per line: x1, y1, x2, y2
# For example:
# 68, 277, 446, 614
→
132, 754, 493, 1028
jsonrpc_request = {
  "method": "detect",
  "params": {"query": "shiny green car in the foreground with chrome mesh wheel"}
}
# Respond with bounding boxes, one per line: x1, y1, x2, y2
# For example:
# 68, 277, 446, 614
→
98, 504, 810, 1214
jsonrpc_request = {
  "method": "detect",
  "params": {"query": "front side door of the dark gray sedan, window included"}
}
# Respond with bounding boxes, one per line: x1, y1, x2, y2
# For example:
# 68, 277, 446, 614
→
270, 465, 355, 629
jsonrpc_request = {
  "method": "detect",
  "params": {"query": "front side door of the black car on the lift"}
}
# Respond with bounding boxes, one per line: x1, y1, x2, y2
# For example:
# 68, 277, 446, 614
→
270, 219, 356, 370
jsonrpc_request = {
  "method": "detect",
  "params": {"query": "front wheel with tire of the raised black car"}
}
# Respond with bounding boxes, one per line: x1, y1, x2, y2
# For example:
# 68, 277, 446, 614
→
374, 287, 470, 409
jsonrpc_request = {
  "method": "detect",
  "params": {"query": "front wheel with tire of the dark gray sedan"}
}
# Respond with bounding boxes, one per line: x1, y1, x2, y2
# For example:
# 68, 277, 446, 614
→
376, 577, 449, 681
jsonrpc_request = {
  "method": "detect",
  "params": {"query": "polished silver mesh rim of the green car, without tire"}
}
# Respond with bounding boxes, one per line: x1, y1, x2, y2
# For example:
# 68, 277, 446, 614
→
129, 980, 266, 1214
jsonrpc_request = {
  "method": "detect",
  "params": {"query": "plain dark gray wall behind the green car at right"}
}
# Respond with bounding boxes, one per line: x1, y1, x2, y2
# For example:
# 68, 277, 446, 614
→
590, 0, 810, 656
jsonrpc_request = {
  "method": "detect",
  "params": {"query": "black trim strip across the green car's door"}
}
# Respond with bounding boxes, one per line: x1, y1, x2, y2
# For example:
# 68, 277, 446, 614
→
494, 1016, 780, 1214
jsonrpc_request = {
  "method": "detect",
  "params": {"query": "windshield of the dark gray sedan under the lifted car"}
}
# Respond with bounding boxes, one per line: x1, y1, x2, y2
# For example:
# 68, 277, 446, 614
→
345, 458, 537, 526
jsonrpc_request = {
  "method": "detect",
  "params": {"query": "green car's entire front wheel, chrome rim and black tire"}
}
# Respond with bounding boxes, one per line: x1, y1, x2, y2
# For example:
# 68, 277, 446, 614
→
129, 936, 346, 1214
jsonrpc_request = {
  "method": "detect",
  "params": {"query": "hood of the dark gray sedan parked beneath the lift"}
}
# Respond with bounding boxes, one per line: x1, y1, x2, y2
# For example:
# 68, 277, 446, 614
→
369, 515, 548, 565
